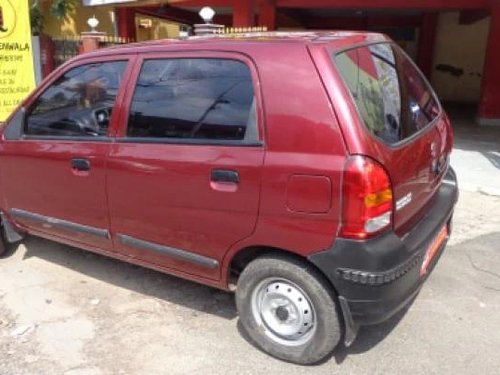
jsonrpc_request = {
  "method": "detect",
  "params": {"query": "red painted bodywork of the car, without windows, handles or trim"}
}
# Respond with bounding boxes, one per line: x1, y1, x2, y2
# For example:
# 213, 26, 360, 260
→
0, 32, 452, 289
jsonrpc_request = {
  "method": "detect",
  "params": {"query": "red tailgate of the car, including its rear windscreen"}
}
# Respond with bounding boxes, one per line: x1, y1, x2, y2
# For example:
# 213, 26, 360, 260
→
334, 43, 452, 232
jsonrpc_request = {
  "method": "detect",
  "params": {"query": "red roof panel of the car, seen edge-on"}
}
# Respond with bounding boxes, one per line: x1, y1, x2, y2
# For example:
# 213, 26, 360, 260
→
83, 31, 390, 57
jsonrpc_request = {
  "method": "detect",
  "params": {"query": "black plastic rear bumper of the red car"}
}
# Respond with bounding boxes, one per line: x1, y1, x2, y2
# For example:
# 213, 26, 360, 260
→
309, 167, 458, 344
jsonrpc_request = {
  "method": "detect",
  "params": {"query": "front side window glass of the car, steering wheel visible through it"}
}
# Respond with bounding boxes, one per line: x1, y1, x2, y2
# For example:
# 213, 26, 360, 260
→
24, 61, 127, 137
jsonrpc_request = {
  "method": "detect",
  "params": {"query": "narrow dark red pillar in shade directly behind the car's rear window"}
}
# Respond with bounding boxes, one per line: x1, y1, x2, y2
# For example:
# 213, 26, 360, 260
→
417, 13, 439, 79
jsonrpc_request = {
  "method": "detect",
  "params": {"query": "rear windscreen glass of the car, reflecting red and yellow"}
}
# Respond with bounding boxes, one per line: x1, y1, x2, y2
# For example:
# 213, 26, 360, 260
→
334, 43, 440, 144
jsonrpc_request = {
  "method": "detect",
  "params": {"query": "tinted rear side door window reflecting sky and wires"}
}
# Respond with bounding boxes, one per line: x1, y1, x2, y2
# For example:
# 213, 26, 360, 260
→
127, 59, 255, 140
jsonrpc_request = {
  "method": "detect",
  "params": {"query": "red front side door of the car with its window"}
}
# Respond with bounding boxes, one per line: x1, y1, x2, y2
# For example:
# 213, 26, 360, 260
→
0, 59, 132, 250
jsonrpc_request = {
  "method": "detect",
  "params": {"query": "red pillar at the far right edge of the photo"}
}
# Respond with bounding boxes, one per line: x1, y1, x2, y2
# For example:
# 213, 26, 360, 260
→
478, 5, 500, 125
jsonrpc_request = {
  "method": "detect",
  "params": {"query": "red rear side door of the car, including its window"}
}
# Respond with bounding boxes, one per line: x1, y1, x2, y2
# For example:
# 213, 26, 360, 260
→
107, 52, 264, 279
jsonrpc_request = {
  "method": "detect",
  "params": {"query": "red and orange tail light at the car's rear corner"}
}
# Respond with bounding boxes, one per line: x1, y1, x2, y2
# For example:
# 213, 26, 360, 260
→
340, 155, 393, 239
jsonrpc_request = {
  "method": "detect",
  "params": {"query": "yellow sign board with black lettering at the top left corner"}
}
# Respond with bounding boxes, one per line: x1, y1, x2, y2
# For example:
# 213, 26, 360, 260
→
0, 0, 35, 121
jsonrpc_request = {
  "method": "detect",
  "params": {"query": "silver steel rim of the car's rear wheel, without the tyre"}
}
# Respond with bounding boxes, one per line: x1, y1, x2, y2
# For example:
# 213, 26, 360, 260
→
252, 279, 316, 346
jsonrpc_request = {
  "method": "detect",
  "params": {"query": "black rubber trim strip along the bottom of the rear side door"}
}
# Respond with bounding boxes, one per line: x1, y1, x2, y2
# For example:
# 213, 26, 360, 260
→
116, 234, 219, 269
